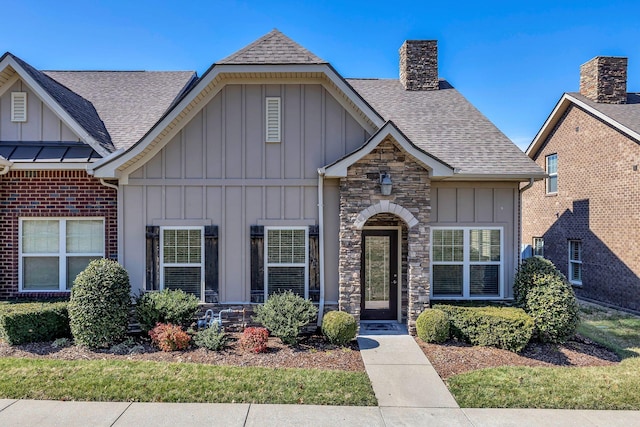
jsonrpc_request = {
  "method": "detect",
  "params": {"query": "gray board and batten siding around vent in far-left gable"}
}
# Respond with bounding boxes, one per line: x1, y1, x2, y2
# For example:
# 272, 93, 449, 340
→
0, 80, 80, 142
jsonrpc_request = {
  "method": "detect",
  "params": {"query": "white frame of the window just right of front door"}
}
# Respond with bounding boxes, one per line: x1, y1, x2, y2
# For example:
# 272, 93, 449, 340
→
429, 226, 505, 300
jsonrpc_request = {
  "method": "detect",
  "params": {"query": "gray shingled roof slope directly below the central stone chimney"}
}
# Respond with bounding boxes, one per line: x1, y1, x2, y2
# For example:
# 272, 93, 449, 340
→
347, 79, 544, 176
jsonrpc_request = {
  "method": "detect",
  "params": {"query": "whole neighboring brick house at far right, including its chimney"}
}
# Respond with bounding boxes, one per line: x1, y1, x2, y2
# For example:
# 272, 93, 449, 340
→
522, 57, 640, 311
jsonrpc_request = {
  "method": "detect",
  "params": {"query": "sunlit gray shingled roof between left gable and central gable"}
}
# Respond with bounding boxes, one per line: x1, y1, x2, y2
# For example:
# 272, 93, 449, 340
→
44, 71, 196, 149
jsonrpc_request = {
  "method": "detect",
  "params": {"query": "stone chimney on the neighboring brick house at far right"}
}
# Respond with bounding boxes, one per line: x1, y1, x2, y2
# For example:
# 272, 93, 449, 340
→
580, 56, 627, 104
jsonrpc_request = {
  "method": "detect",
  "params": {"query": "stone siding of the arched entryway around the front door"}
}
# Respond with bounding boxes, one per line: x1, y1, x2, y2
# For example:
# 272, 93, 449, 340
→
339, 139, 431, 333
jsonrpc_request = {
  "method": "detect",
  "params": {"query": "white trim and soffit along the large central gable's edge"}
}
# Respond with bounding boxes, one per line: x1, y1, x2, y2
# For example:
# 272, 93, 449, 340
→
90, 64, 384, 179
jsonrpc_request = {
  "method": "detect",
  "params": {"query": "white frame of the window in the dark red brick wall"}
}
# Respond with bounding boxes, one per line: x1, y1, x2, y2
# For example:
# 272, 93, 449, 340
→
18, 216, 107, 293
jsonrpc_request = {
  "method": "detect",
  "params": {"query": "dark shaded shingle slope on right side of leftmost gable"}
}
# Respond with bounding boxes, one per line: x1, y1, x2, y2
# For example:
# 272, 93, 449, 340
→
11, 55, 114, 152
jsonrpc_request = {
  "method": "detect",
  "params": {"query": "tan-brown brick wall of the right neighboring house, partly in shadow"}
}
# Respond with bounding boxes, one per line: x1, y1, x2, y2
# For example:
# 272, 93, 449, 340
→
522, 106, 640, 310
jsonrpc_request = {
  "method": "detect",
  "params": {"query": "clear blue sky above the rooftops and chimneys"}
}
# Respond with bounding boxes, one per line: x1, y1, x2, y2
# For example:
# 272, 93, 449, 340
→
5, 0, 640, 149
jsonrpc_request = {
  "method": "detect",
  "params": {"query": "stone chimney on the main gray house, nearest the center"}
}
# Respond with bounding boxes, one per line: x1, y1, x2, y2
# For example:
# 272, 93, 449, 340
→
400, 40, 439, 90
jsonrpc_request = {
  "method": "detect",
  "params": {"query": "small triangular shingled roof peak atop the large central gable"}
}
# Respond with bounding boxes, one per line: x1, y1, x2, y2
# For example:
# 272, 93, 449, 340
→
217, 29, 327, 65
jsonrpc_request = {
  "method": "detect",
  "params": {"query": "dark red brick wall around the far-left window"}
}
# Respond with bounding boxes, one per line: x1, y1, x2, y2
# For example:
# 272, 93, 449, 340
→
0, 171, 118, 299
